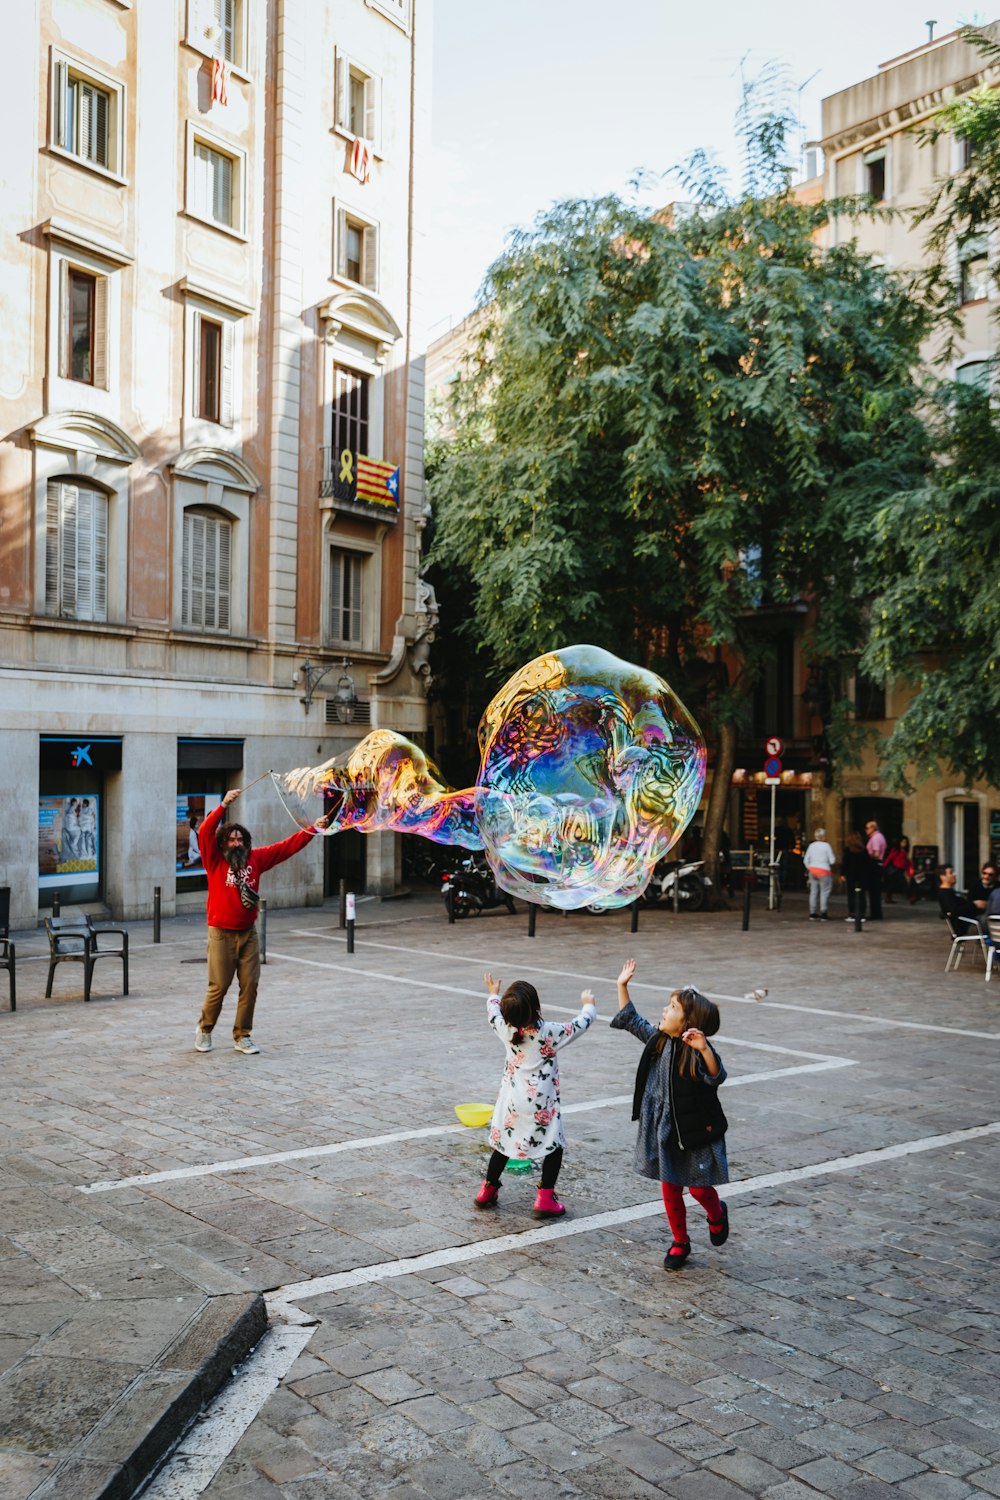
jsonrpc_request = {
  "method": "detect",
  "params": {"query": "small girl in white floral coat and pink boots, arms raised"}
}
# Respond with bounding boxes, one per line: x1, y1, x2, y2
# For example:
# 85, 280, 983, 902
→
475, 974, 597, 1218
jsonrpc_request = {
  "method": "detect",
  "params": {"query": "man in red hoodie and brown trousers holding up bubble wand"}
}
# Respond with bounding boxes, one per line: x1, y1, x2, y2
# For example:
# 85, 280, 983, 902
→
195, 788, 325, 1056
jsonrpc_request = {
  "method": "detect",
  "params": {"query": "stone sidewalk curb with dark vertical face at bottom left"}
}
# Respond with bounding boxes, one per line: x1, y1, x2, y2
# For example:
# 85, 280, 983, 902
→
30, 1292, 267, 1500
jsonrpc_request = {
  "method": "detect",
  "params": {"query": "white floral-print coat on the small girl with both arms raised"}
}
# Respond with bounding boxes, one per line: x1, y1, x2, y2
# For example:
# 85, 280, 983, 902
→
486, 995, 597, 1161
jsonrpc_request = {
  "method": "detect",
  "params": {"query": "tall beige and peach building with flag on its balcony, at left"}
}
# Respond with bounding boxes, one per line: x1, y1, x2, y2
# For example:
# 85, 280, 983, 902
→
0, 0, 433, 926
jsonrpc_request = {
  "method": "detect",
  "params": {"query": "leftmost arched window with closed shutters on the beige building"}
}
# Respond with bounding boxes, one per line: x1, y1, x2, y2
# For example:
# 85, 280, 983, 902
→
45, 477, 108, 620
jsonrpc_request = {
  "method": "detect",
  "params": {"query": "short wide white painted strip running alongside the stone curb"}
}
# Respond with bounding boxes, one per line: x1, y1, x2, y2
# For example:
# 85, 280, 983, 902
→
134, 1320, 315, 1500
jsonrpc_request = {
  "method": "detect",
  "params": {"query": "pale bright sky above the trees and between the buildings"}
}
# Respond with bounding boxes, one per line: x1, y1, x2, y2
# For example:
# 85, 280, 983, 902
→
424, 0, 1000, 339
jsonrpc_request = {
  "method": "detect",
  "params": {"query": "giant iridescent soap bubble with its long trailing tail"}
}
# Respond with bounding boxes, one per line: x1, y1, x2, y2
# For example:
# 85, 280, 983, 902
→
274, 645, 705, 911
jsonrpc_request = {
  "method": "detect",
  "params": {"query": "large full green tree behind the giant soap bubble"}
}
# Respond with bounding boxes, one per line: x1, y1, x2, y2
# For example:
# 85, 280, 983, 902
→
430, 117, 927, 888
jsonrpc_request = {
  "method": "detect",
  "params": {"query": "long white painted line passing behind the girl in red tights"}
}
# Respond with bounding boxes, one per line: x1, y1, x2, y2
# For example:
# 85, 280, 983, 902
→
271, 1121, 1000, 1308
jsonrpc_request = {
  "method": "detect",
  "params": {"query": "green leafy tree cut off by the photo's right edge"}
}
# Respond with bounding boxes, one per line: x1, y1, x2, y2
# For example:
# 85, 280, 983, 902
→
862, 29, 1000, 788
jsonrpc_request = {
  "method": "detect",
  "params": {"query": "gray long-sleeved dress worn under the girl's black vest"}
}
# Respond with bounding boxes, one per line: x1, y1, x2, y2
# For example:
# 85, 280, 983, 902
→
612, 1001, 729, 1188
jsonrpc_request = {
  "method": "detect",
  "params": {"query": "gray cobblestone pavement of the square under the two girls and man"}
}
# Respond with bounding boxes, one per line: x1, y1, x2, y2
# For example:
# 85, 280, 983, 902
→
0, 900, 1000, 1500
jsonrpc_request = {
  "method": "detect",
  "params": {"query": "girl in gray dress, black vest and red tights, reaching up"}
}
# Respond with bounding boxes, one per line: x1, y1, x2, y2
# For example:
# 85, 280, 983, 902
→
612, 959, 729, 1271
